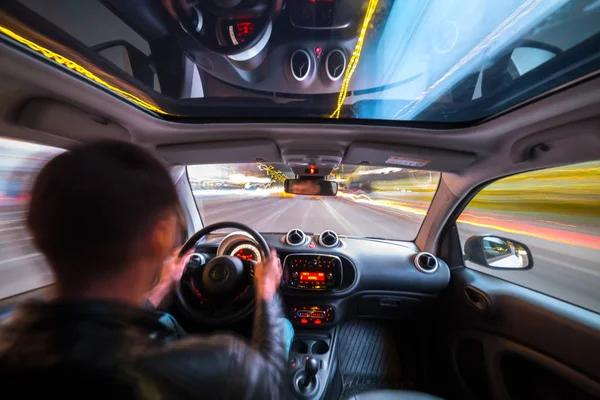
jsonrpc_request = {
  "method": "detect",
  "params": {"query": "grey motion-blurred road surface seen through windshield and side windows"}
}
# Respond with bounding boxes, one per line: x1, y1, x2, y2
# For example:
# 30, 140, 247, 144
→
0, 192, 600, 311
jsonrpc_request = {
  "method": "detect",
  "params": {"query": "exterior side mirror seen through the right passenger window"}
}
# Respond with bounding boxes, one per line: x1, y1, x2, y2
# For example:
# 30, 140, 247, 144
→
465, 235, 533, 270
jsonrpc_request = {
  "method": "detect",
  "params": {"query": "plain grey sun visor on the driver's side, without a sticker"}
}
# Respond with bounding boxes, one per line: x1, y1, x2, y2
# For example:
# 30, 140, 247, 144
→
156, 140, 281, 165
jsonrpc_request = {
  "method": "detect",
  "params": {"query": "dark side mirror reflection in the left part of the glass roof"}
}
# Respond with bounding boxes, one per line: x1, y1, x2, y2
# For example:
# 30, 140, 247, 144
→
92, 40, 154, 88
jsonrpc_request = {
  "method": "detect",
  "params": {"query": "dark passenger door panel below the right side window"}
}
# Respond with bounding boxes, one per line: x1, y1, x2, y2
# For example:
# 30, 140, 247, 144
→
442, 267, 600, 399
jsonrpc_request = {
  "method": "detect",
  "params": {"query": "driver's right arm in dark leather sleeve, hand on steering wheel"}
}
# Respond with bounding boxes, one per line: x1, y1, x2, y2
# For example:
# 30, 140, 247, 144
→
131, 252, 290, 400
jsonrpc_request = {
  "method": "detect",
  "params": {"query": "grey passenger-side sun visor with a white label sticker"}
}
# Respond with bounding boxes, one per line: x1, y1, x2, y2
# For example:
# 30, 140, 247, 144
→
344, 142, 477, 172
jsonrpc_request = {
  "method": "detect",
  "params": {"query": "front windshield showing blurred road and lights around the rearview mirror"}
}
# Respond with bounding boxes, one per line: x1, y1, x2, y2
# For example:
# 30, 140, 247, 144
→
188, 164, 440, 240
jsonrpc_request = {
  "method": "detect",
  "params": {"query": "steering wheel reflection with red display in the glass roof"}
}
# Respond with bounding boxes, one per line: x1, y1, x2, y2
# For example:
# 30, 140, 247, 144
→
169, 0, 282, 57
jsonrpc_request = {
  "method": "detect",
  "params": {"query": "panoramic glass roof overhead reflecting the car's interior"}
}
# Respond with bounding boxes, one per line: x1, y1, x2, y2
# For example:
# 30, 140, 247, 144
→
0, 0, 600, 123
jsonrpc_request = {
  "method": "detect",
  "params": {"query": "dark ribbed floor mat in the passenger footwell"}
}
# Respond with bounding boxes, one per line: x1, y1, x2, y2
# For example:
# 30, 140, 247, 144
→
337, 321, 412, 398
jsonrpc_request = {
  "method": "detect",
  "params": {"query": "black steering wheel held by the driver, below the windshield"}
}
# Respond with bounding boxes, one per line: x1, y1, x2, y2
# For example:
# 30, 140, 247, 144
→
175, 222, 271, 326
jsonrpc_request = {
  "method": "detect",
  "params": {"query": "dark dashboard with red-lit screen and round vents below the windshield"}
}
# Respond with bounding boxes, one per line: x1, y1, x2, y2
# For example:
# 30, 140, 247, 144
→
190, 229, 450, 327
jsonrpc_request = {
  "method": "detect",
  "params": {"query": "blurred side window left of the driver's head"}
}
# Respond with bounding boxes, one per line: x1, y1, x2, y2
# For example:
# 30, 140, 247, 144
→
0, 138, 62, 299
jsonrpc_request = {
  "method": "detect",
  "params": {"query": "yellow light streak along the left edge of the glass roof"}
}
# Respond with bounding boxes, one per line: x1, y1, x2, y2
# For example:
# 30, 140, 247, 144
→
0, 25, 174, 115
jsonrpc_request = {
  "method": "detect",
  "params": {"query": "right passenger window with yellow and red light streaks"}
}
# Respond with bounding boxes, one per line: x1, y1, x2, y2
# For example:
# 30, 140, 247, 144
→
457, 162, 600, 312
